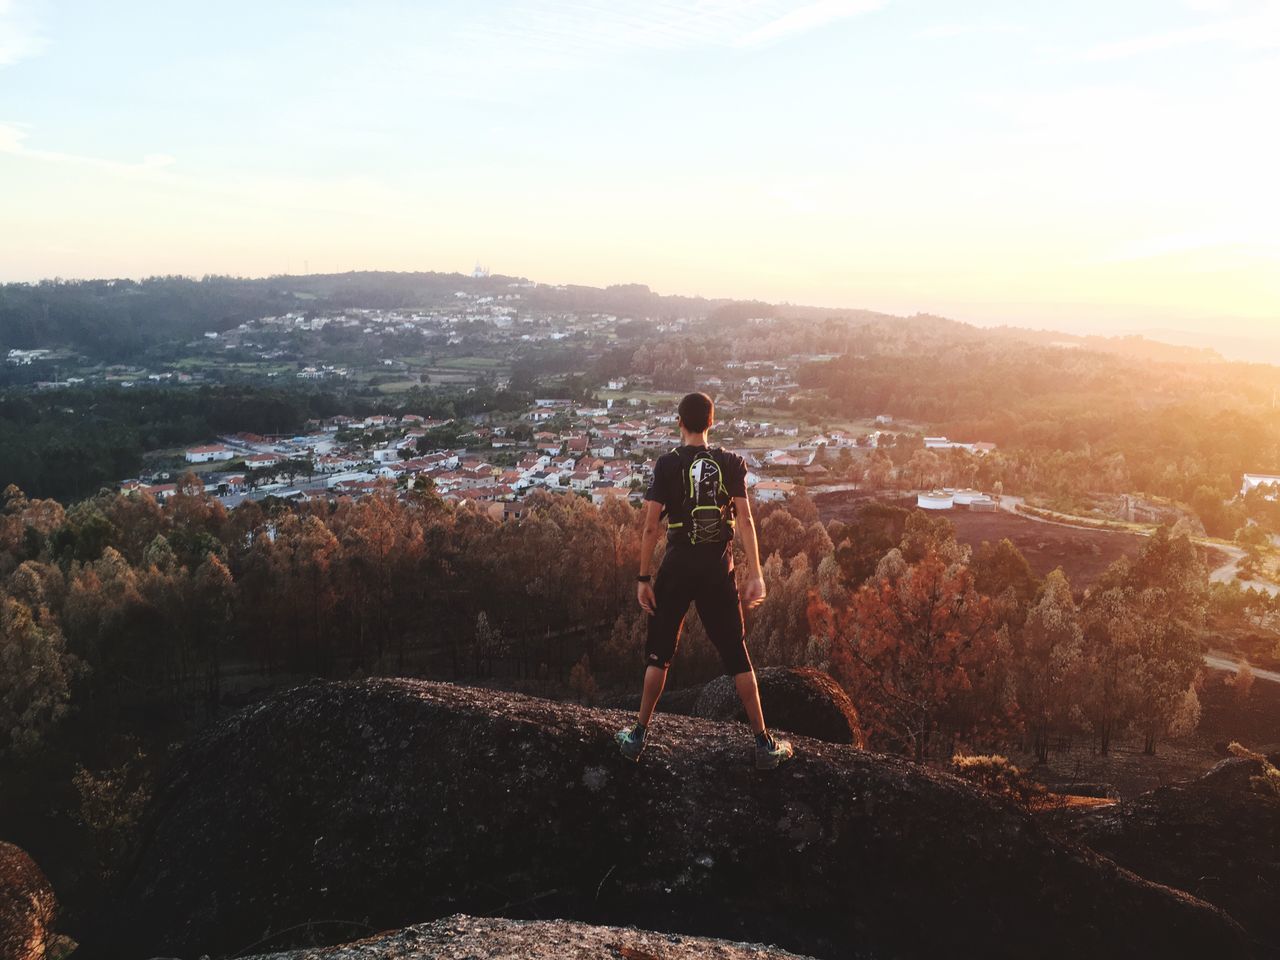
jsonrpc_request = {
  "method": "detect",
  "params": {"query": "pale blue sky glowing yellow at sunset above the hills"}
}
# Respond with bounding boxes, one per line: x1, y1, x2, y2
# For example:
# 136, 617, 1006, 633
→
0, 0, 1280, 340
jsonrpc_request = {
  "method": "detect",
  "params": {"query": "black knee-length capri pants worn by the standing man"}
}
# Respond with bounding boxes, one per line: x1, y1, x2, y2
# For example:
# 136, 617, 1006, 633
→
644, 541, 751, 675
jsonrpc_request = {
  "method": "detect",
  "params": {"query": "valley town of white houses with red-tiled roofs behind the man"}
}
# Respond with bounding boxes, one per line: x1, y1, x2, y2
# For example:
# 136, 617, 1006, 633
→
132, 399, 877, 516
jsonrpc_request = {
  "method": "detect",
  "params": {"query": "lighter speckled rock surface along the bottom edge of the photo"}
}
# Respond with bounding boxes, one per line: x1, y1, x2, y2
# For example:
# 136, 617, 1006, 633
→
243, 914, 804, 960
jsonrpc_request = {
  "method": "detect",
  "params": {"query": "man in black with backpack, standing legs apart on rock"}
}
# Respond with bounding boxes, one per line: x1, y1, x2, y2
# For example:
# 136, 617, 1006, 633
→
617, 393, 794, 769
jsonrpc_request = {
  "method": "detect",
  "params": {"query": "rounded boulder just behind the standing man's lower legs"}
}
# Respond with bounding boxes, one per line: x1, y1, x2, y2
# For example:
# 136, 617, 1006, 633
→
692, 667, 863, 746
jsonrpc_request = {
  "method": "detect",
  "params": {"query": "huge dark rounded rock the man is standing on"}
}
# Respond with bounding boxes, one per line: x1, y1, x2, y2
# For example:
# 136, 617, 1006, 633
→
114, 680, 1251, 960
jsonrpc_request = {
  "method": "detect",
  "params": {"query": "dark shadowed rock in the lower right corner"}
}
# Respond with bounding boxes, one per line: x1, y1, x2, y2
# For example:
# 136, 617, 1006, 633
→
1056, 758, 1280, 956
